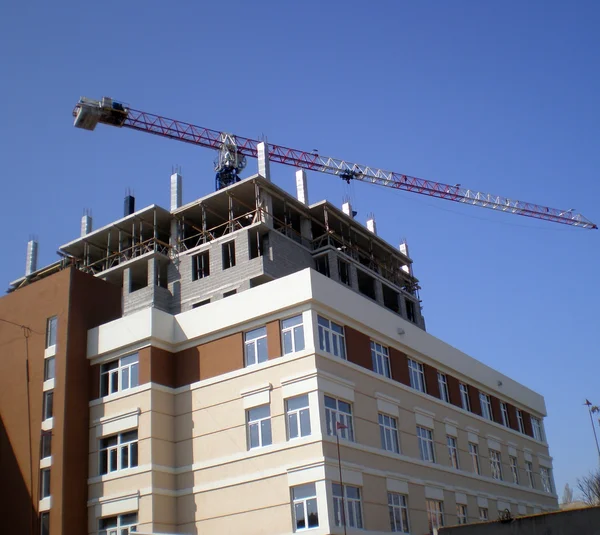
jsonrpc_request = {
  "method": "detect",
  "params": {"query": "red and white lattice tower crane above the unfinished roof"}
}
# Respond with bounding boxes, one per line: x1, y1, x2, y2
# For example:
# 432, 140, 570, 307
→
73, 97, 598, 229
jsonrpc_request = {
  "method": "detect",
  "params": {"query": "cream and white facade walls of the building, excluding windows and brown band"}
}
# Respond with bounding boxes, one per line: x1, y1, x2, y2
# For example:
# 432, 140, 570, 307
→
88, 269, 557, 535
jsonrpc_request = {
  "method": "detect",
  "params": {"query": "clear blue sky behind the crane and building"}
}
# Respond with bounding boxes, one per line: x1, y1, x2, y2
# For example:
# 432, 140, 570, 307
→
0, 0, 600, 500
